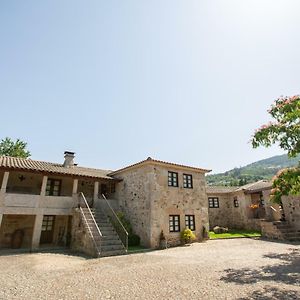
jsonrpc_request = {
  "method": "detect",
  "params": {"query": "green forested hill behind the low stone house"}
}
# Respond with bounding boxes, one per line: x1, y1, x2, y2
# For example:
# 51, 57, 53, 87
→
206, 154, 300, 186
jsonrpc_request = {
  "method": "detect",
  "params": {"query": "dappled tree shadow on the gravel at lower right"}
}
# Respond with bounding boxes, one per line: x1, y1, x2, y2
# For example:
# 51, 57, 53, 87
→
221, 249, 300, 300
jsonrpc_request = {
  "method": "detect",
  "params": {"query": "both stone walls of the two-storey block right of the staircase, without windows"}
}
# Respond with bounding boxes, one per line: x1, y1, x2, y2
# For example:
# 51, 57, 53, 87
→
115, 162, 208, 248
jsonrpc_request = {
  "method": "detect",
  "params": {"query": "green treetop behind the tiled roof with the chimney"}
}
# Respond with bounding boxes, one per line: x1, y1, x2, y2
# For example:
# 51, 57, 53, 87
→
0, 137, 31, 158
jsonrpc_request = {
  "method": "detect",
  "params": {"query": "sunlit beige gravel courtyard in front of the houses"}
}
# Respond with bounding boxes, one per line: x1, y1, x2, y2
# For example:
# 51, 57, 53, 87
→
0, 239, 300, 300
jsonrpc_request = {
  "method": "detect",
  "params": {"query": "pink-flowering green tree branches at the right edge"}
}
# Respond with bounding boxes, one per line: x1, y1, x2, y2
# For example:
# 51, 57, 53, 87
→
252, 95, 300, 203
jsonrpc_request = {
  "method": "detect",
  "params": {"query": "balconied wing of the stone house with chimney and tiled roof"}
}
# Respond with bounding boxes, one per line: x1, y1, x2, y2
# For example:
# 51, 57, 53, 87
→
0, 152, 115, 250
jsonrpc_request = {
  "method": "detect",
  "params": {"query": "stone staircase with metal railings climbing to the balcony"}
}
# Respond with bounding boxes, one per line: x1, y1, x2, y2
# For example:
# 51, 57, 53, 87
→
82, 208, 126, 257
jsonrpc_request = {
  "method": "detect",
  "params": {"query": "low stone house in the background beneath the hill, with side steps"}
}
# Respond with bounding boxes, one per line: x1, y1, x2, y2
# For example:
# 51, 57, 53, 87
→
206, 180, 300, 240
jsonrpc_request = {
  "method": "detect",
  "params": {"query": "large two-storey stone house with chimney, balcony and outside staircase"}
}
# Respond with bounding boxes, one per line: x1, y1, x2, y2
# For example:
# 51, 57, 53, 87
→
0, 152, 209, 256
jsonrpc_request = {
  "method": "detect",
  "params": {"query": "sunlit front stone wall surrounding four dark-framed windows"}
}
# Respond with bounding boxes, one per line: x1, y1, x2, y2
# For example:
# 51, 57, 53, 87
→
151, 165, 208, 247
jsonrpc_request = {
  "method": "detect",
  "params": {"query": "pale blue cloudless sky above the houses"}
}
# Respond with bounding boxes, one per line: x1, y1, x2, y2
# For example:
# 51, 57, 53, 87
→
0, 0, 300, 172
